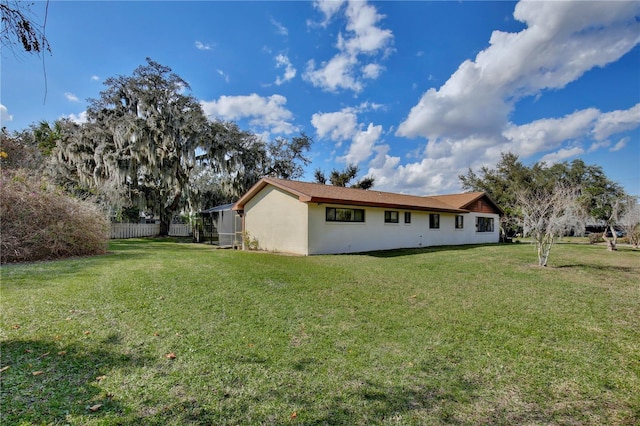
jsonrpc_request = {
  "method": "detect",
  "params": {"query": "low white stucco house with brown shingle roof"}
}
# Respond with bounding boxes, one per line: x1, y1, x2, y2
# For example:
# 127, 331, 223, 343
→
233, 178, 502, 255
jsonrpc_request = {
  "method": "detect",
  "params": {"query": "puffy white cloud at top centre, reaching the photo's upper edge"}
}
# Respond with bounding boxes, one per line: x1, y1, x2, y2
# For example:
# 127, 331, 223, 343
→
303, 0, 393, 93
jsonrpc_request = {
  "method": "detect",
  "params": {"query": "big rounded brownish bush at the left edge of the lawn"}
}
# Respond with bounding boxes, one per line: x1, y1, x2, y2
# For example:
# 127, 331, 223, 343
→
0, 170, 109, 263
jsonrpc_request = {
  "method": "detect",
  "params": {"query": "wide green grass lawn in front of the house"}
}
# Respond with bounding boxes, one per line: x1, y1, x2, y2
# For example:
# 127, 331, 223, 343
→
0, 240, 640, 425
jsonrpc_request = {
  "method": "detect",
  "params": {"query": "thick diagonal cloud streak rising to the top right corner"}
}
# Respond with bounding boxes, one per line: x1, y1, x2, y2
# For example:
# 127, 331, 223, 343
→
398, 1, 640, 139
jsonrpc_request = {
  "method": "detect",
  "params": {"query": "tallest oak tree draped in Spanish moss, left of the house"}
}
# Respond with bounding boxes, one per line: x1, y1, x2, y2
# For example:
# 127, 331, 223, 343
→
57, 59, 212, 235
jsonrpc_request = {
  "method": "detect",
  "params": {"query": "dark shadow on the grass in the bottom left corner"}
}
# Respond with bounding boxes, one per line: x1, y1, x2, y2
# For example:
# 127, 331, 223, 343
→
0, 335, 147, 424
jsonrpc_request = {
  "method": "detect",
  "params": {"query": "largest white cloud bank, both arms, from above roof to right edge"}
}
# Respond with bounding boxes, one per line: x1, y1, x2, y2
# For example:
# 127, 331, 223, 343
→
376, 1, 640, 194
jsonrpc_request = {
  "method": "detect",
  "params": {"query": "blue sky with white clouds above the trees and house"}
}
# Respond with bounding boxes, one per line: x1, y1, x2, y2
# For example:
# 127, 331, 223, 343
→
0, 0, 640, 195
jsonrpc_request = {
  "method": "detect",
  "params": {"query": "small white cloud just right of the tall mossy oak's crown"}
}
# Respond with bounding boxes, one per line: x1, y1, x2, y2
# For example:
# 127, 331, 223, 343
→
201, 93, 298, 134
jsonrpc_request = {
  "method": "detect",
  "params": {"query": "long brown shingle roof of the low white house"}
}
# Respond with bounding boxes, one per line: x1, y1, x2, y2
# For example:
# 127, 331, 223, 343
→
233, 178, 476, 213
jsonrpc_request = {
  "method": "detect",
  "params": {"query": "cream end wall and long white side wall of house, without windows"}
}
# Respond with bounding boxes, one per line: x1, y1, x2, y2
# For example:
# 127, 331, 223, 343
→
244, 185, 500, 255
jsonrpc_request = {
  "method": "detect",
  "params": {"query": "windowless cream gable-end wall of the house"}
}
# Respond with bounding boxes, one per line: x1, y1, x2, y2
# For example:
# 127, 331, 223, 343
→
244, 185, 309, 255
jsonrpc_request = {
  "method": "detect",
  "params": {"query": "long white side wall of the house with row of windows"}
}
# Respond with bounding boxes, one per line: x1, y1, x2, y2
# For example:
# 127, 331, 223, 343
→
308, 204, 499, 254
